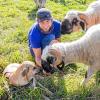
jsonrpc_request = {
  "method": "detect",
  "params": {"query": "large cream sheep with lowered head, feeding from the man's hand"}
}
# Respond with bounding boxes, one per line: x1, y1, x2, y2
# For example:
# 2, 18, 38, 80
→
41, 24, 100, 85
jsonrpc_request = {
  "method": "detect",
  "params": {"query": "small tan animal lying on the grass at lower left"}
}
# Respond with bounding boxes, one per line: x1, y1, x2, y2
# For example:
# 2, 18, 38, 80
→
3, 61, 39, 86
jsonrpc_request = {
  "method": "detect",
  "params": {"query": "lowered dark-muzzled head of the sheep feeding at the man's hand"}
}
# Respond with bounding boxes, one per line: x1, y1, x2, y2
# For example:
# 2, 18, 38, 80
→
41, 46, 63, 74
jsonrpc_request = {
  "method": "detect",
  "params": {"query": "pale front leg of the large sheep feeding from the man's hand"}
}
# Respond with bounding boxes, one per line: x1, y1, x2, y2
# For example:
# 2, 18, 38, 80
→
82, 67, 94, 86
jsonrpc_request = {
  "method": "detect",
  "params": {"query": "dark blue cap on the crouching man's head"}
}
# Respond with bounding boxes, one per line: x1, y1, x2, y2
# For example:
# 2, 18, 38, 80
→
37, 8, 52, 21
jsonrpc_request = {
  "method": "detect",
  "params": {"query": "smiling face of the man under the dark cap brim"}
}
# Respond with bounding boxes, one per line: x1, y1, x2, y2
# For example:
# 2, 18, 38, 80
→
39, 20, 52, 32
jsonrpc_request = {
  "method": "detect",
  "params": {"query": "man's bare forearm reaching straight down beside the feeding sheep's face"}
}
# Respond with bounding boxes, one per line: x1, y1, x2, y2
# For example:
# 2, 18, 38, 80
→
32, 48, 41, 66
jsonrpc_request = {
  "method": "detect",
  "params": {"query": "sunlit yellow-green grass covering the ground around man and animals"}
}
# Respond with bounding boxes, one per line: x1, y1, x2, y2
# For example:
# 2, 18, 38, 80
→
0, 0, 99, 100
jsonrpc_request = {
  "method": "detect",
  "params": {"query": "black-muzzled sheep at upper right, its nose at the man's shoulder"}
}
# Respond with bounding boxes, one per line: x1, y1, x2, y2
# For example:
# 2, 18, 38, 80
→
61, 0, 100, 34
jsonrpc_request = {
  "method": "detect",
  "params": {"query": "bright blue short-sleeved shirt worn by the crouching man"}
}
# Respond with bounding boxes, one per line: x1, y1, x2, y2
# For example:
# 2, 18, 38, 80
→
28, 20, 61, 48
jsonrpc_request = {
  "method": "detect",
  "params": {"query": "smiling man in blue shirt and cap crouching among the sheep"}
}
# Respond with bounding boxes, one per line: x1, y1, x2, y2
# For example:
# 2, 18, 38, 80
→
28, 8, 61, 67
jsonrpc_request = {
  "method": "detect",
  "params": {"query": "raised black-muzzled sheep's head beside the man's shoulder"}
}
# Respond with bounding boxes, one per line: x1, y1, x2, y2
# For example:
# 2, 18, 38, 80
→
61, 10, 86, 34
